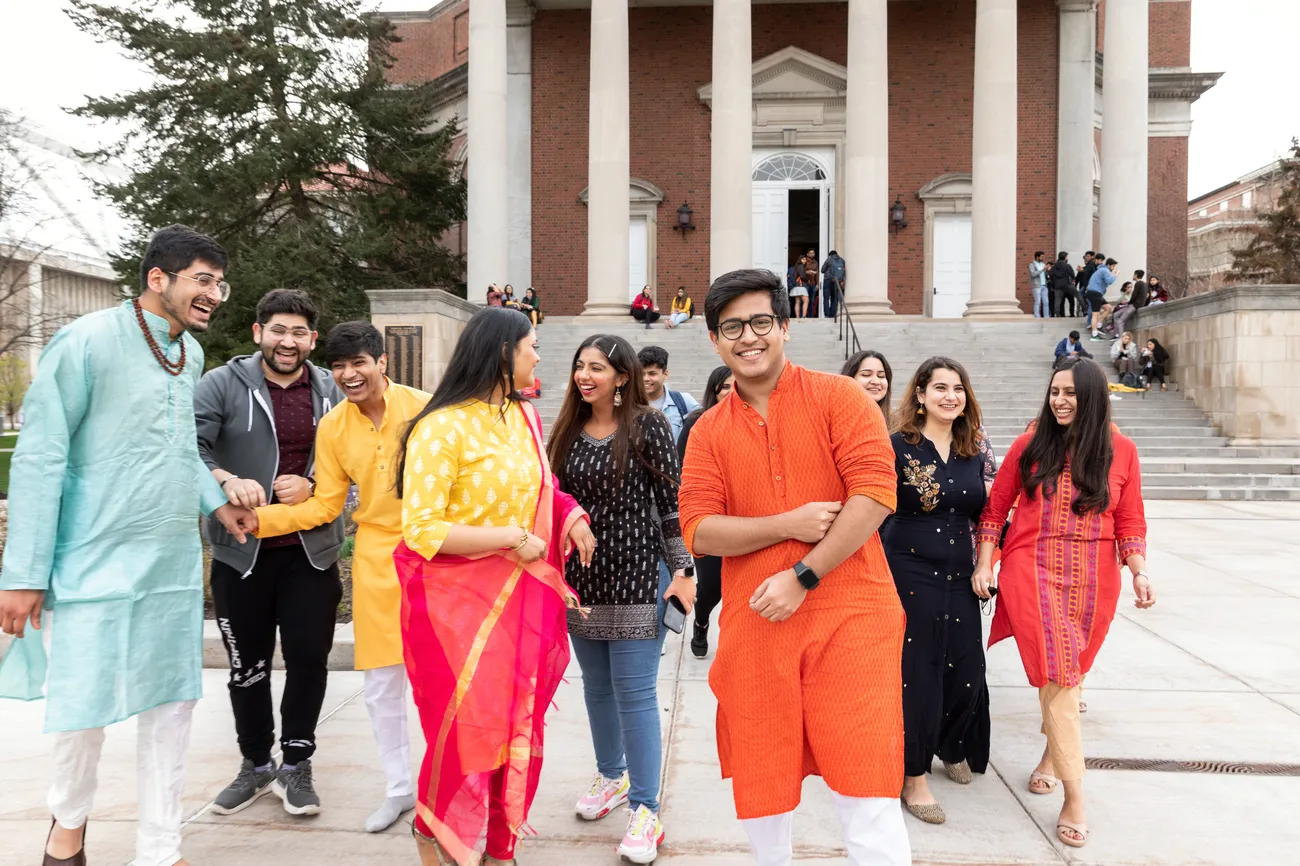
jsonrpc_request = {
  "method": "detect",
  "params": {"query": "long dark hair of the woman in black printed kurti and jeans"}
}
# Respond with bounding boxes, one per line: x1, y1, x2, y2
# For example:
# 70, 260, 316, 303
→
546, 334, 677, 488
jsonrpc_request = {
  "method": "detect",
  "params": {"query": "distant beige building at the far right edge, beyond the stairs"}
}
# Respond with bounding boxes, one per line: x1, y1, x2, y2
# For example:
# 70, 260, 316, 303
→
1187, 160, 1282, 295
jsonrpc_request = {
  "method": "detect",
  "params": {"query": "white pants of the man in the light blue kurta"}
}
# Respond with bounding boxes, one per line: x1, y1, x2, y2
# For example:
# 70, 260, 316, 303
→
49, 701, 196, 866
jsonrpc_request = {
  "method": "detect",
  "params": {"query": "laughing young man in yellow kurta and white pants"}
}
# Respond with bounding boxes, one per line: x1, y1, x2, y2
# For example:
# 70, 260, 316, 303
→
256, 321, 429, 833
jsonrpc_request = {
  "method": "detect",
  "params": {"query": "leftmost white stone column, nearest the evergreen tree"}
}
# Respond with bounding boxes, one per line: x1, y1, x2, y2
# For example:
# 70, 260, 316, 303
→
465, 0, 510, 304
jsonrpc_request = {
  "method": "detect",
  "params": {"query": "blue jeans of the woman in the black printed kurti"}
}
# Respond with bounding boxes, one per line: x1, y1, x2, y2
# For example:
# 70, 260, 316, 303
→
571, 562, 672, 813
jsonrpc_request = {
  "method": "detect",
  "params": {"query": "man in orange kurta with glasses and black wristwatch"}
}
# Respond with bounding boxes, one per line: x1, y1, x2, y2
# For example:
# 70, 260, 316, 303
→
679, 270, 911, 866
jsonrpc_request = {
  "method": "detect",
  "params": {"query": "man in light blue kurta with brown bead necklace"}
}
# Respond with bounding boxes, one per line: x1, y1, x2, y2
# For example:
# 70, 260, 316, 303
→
0, 226, 252, 866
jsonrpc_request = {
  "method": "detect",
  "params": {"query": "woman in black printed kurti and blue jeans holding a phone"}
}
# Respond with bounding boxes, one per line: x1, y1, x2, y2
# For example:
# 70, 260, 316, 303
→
547, 334, 696, 863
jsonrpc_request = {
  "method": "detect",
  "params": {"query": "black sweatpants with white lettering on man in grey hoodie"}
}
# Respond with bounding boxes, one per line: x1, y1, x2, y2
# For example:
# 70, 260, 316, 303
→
212, 545, 343, 766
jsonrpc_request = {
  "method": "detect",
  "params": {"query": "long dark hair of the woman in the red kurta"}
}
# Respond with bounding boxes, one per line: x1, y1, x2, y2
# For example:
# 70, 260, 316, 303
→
1019, 358, 1115, 515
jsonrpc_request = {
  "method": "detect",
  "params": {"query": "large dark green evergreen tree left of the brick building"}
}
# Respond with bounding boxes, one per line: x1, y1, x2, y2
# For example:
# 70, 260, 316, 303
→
69, 0, 465, 367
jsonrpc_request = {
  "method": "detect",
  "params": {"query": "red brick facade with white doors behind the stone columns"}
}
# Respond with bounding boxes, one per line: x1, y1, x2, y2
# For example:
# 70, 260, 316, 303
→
390, 0, 1216, 316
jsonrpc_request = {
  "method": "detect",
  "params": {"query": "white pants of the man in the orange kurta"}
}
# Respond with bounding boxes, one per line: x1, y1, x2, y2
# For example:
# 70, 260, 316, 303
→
741, 791, 911, 866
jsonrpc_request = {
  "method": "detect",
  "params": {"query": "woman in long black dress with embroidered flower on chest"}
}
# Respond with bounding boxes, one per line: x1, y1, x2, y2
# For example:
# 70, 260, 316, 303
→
885, 358, 996, 824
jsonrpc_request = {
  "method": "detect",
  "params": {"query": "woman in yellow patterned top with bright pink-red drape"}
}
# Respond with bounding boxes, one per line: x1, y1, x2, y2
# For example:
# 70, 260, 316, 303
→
394, 307, 595, 866
